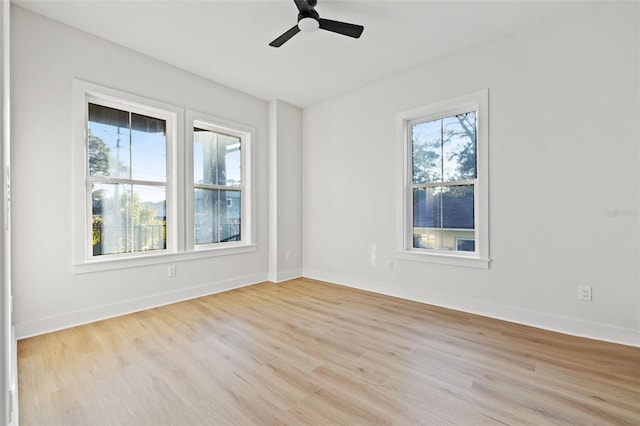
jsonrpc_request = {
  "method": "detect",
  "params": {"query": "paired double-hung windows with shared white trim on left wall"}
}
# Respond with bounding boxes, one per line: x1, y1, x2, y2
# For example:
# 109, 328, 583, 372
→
73, 80, 255, 272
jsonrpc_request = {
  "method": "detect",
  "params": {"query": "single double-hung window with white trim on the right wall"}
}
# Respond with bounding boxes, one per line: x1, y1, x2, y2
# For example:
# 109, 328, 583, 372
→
398, 91, 488, 267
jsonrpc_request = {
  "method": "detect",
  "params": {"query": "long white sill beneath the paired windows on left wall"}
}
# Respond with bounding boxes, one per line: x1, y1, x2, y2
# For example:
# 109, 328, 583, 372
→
73, 245, 257, 274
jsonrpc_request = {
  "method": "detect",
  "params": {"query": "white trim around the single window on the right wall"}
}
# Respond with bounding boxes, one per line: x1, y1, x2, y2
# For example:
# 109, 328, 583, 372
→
396, 89, 490, 269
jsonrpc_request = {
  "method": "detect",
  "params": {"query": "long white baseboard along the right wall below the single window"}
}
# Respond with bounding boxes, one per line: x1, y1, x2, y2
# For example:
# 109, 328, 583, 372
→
303, 269, 640, 347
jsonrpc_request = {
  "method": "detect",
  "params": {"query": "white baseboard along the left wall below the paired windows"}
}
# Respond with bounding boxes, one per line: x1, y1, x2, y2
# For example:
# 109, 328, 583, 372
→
15, 274, 267, 340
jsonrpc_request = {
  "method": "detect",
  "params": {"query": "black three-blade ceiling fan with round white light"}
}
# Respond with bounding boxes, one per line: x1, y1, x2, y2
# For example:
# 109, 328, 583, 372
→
269, 0, 364, 47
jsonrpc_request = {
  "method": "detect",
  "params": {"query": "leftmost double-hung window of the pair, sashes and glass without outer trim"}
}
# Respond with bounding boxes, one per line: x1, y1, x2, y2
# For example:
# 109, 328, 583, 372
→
86, 101, 173, 258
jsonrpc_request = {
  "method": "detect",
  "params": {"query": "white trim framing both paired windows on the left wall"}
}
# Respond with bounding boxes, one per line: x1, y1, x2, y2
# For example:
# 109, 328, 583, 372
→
71, 79, 257, 274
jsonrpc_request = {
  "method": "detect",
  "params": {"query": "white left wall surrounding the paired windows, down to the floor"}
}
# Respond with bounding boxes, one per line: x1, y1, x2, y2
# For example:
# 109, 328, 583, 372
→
11, 7, 268, 337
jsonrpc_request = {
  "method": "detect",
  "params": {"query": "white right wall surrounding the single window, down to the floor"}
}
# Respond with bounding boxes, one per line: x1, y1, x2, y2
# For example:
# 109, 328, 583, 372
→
303, 2, 640, 345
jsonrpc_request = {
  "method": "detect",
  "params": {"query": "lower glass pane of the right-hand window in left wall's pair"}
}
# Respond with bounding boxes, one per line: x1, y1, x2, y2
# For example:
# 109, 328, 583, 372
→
194, 188, 242, 244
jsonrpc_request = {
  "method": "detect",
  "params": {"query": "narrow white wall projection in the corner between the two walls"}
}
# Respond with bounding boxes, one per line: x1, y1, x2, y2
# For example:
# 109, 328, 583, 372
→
269, 100, 302, 282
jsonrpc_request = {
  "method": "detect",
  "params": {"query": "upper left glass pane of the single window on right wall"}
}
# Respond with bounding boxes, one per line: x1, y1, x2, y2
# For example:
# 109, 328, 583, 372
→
411, 120, 442, 184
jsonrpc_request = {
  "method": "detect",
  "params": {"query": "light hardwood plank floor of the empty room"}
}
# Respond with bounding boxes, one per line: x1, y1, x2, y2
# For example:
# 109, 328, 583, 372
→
18, 279, 640, 425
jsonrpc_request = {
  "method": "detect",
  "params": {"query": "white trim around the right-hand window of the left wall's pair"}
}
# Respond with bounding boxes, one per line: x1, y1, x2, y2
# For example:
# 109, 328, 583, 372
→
184, 110, 255, 253
